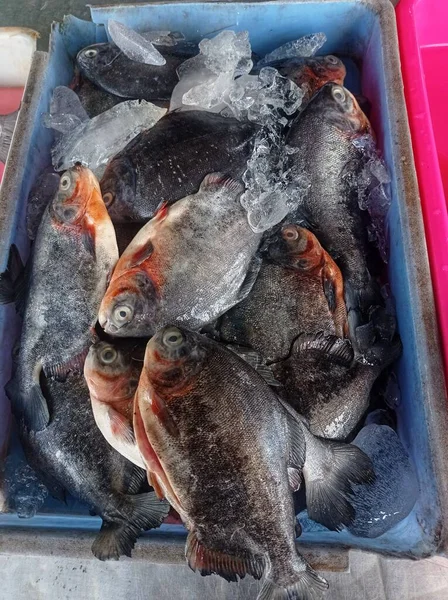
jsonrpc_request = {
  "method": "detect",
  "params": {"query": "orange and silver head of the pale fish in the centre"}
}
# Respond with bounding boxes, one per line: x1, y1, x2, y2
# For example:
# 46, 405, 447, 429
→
98, 267, 159, 337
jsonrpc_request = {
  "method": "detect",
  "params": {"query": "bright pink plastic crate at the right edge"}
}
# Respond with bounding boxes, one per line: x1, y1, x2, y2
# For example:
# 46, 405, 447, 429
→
396, 0, 448, 380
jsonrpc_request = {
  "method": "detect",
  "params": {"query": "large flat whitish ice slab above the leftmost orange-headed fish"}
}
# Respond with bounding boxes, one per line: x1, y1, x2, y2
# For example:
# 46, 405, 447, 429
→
51, 100, 166, 177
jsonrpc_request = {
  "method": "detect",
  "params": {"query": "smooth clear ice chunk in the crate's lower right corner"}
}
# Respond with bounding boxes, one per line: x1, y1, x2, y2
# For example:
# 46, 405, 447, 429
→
349, 424, 419, 538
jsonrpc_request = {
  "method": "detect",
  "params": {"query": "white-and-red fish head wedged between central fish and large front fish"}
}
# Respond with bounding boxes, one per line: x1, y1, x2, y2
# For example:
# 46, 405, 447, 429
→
84, 341, 143, 404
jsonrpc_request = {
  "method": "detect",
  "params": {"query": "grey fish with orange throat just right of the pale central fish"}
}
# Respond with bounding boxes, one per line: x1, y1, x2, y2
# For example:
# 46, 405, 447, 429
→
219, 223, 348, 363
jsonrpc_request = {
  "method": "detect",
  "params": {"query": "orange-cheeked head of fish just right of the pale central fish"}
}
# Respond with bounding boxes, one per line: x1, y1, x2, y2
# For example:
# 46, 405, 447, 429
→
268, 223, 323, 270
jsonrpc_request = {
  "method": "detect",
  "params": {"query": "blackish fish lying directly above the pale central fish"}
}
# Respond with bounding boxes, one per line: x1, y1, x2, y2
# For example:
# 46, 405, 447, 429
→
100, 111, 259, 222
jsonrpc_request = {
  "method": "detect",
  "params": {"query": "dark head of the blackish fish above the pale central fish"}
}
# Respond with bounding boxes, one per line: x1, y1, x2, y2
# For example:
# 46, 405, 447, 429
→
100, 156, 136, 220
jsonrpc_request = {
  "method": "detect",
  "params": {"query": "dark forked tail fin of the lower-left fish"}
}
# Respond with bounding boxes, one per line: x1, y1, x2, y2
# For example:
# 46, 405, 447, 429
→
92, 492, 170, 560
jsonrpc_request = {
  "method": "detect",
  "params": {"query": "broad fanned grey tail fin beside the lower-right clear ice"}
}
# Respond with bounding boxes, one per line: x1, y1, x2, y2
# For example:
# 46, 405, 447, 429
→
303, 426, 375, 531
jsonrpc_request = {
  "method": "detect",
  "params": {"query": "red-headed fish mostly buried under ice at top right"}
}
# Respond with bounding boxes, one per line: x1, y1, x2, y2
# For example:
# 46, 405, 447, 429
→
257, 54, 347, 108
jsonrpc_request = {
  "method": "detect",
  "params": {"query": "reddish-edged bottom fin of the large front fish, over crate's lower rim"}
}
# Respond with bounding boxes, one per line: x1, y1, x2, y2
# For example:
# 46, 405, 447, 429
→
185, 530, 264, 581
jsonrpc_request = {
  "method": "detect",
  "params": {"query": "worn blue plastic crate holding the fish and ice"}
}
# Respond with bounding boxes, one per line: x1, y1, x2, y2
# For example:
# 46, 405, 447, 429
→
0, 0, 448, 557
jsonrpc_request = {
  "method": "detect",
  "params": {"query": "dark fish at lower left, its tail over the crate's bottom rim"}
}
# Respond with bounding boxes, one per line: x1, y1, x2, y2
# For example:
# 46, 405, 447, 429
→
20, 373, 169, 560
